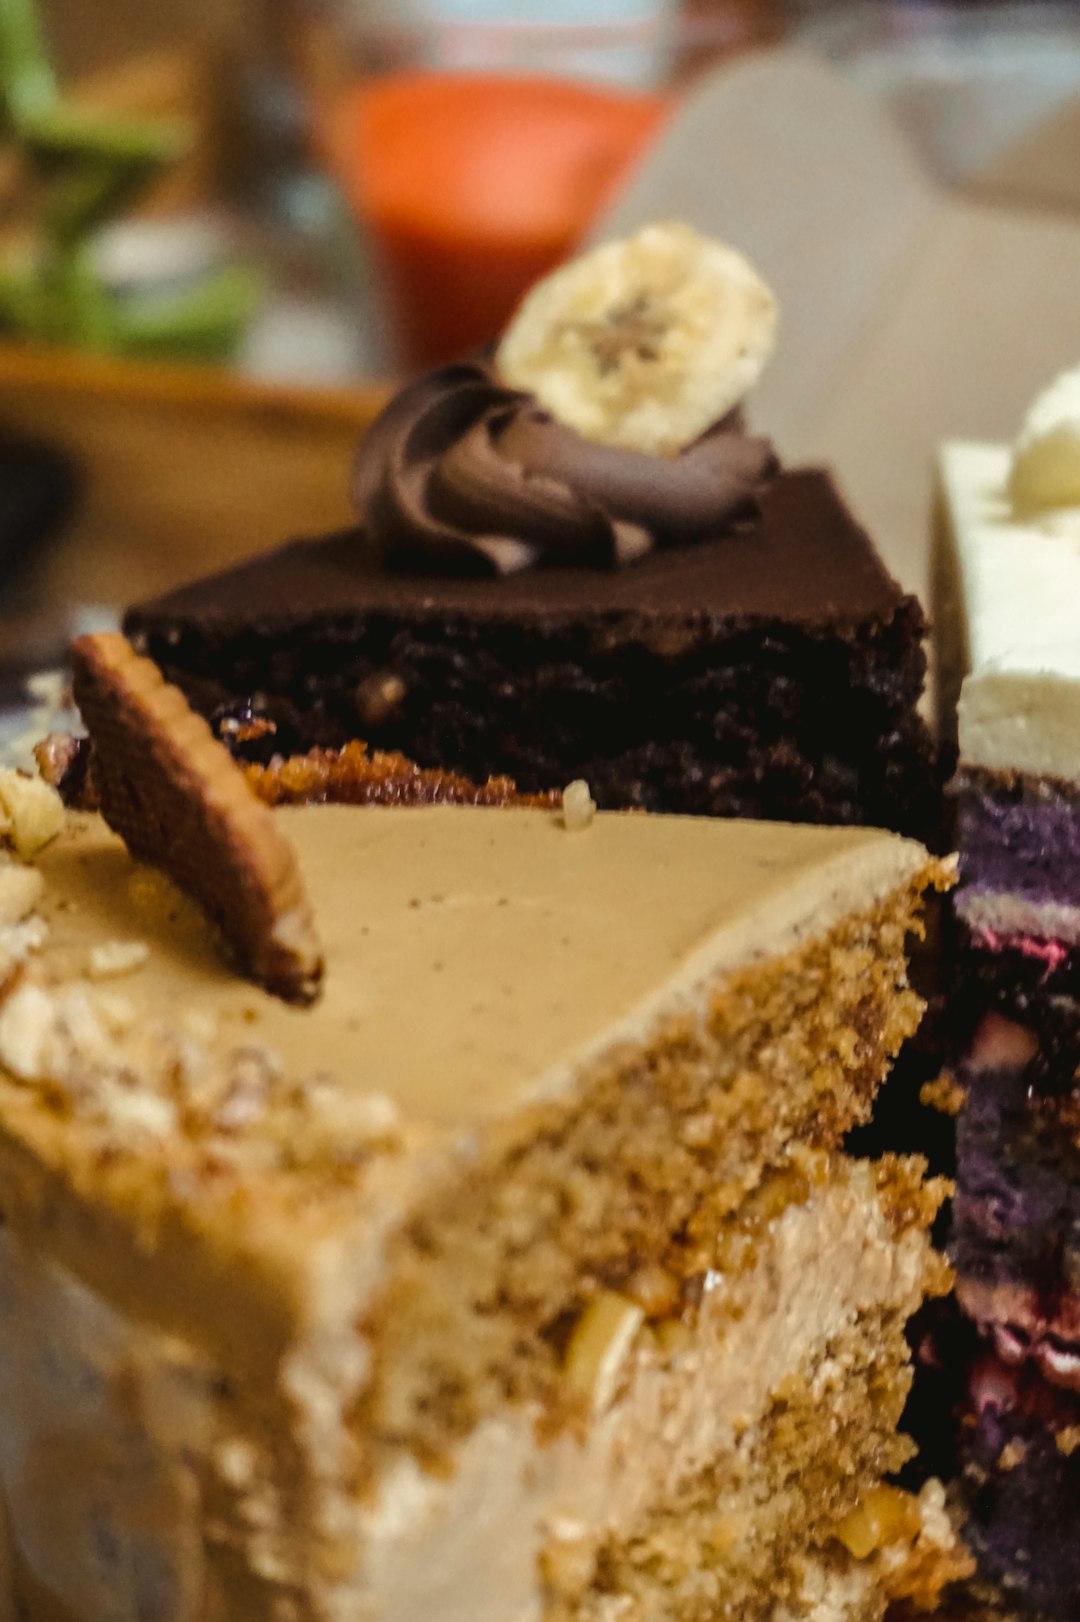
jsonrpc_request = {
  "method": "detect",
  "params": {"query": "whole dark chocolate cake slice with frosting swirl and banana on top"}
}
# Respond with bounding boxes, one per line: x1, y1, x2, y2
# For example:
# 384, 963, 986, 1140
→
125, 225, 939, 834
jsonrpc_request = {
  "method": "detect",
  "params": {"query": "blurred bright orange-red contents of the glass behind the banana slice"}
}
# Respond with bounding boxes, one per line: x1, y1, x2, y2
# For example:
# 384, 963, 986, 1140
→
334, 71, 670, 370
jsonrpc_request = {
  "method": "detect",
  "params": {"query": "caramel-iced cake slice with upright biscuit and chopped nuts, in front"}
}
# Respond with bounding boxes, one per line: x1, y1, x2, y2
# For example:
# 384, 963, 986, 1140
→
0, 637, 963, 1622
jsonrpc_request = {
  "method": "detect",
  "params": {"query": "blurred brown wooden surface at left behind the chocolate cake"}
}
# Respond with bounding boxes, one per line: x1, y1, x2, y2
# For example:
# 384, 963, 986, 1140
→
0, 345, 386, 649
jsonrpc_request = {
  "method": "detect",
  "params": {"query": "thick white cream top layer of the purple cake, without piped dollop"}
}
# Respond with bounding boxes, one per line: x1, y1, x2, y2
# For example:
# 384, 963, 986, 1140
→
941, 443, 1080, 783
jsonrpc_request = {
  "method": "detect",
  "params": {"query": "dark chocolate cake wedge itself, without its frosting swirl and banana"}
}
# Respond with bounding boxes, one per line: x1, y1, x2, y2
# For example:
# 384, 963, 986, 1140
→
125, 470, 939, 834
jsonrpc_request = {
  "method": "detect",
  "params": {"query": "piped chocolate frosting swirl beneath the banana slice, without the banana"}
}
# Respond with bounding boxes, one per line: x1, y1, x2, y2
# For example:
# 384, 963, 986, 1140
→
352, 357, 777, 574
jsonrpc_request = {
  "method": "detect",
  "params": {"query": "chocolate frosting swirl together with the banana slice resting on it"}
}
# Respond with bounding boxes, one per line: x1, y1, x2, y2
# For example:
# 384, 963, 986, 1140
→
354, 224, 777, 574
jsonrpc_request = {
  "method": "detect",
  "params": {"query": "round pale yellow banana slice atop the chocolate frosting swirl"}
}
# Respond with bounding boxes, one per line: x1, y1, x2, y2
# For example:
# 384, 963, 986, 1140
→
495, 222, 777, 456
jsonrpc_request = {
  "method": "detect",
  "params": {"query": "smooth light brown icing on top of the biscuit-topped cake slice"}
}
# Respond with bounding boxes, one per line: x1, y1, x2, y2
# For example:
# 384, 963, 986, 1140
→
21, 806, 924, 1129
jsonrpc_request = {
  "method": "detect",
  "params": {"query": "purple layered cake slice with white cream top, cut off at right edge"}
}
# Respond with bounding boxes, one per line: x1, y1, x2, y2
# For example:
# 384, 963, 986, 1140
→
941, 373, 1080, 1622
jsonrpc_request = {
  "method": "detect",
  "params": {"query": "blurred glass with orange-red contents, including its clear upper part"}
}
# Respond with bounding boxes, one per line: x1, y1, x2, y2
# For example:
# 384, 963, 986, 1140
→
285, 0, 675, 371
